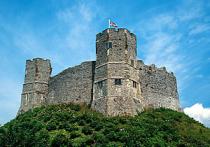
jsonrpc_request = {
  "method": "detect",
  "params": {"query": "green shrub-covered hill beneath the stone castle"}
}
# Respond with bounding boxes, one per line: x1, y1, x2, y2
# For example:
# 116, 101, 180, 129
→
0, 104, 210, 147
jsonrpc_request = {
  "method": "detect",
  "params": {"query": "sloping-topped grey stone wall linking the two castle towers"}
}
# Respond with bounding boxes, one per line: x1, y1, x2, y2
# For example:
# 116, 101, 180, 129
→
47, 61, 95, 105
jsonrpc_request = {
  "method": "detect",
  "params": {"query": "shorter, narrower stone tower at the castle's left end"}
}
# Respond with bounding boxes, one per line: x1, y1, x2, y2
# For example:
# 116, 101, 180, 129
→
18, 58, 51, 113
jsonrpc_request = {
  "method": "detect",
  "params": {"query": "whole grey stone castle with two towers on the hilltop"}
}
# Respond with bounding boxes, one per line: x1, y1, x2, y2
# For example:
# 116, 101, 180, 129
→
18, 28, 180, 116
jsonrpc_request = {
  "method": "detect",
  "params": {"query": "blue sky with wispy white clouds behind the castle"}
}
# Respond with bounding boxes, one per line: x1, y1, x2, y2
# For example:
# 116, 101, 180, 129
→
0, 0, 210, 126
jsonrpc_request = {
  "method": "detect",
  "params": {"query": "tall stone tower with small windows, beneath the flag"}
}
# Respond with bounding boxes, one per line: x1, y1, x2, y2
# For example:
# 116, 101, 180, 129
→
92, 28, 144, 116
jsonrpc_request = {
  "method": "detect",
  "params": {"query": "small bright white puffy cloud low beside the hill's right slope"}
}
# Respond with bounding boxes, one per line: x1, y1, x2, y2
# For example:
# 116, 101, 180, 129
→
184, 103, 210, 127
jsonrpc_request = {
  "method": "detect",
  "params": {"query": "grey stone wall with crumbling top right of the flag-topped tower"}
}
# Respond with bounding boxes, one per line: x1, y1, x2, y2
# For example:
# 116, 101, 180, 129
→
139, 61, 180, 110
